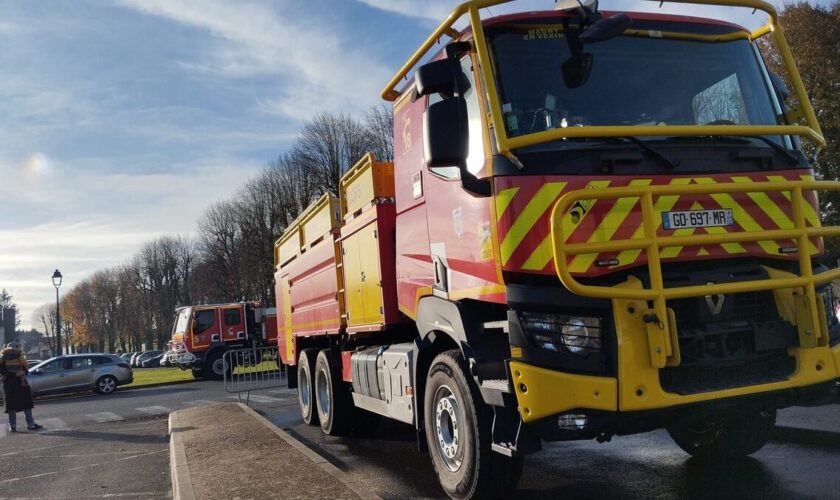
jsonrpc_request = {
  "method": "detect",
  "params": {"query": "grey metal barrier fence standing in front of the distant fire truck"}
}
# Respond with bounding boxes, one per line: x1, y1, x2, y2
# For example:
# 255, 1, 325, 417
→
222, 347, 286, 405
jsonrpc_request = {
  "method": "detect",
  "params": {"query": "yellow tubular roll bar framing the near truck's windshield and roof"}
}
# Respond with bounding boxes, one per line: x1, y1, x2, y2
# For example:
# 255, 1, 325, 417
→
381, 0, 825, 150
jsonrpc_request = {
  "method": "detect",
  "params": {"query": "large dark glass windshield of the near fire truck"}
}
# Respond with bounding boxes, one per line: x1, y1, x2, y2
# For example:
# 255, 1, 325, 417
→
487, 20, 782, 148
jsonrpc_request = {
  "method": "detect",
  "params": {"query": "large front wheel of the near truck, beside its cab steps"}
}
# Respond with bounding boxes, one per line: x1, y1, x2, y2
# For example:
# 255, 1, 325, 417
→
423, 349, 523, 499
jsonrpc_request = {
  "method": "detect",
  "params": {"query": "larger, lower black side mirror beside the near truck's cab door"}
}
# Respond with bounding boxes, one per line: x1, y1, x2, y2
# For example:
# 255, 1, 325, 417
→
423, 96, 469, 172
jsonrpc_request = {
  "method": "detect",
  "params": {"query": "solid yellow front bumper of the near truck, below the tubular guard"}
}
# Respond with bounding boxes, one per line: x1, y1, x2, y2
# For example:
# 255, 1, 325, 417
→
510, 345, 840, 423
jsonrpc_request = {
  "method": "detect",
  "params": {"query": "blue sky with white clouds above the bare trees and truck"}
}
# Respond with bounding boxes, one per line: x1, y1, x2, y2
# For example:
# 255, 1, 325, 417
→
0, 0, 812, 327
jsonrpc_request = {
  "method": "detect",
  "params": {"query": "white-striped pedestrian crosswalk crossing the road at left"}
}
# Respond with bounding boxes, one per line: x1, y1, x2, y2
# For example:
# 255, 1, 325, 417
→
0, 389, 296, 437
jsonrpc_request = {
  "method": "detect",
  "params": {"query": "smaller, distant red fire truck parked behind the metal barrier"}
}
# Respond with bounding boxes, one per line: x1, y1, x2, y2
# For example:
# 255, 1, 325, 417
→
164, 302, 277, 380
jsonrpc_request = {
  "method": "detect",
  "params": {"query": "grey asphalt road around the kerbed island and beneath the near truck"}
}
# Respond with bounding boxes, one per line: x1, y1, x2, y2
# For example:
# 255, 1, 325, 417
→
0, 382, 840, 499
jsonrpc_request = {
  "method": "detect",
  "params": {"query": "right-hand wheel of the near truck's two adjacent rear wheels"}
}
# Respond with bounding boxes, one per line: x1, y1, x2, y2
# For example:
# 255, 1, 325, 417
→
314, 349, 353, 436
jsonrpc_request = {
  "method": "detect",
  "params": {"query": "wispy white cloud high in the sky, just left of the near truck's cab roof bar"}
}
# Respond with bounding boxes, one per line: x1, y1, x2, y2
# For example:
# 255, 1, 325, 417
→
112, 0, 389, 119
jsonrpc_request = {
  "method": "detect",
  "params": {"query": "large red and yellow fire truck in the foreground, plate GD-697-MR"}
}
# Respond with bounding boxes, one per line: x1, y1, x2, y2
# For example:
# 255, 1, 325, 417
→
275, 0, 840, 498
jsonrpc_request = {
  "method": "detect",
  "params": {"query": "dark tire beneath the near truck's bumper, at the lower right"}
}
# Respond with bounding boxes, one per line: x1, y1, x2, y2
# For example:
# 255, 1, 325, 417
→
668, 410, 776, 461
